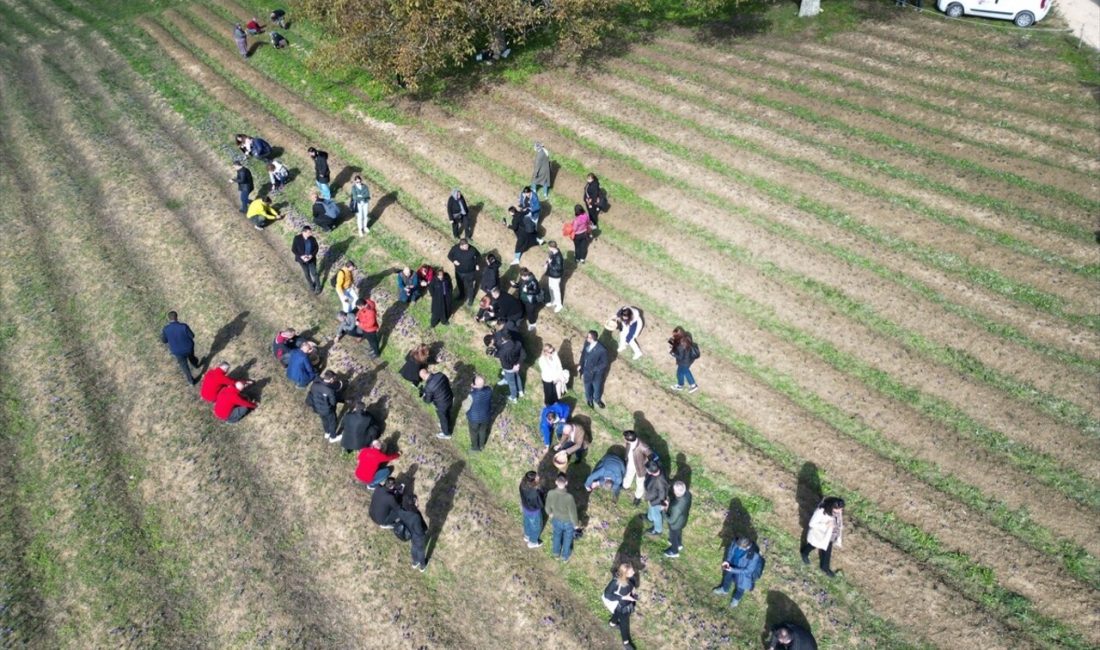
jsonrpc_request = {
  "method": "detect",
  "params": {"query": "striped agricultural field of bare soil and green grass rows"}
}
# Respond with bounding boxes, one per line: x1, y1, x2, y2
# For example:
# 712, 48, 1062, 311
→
0, 0, 1100, 650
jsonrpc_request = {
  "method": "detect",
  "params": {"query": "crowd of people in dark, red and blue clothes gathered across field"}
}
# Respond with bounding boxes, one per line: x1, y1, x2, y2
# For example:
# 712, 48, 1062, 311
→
162, 109, 827, 649
